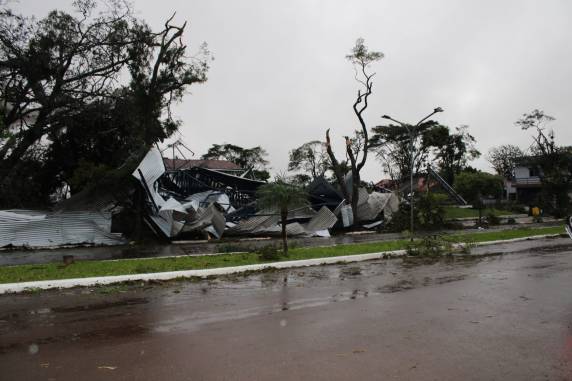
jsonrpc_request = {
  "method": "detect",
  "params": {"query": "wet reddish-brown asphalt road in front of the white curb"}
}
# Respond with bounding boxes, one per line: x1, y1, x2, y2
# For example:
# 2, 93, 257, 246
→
0, 239, 572, 380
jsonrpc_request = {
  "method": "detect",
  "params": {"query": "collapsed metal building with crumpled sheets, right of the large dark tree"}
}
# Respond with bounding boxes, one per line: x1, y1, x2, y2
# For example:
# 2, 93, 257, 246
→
133, 149, 398, 239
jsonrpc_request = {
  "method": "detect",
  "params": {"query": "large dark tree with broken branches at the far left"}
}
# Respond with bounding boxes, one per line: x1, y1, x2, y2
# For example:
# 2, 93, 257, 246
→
0, 0, 209, 204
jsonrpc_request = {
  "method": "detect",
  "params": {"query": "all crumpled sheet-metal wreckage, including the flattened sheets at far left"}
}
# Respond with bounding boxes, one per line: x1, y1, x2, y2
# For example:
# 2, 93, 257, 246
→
0, 148, 399, 247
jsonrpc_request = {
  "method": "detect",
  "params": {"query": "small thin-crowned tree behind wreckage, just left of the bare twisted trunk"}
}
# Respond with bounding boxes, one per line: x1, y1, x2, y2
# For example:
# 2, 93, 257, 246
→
288, 140, 331, 179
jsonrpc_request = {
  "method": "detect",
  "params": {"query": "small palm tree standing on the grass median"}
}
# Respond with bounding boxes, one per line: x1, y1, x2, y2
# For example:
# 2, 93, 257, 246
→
256, 178, 308, 255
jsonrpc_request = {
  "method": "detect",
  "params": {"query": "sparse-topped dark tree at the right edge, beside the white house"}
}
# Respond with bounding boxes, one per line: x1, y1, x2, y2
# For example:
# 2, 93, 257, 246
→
516, 109, 572, 216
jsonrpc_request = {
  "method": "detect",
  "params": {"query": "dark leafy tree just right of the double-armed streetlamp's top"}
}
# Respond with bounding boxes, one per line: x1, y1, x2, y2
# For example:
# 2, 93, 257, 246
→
434, 126, 481, 184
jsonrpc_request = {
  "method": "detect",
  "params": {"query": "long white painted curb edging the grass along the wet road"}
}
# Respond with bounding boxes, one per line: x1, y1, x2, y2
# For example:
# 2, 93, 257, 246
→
0, 234, 560, 294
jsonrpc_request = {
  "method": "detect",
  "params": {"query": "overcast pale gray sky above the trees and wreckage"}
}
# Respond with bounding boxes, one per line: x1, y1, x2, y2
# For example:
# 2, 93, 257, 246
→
12, 0, 572, 180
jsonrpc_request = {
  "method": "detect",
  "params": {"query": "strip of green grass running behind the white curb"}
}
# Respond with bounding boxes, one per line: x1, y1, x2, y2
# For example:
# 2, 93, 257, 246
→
0, 226, 564, 283
